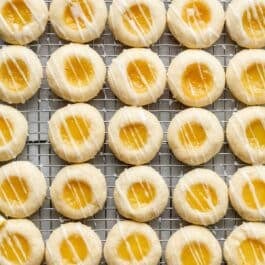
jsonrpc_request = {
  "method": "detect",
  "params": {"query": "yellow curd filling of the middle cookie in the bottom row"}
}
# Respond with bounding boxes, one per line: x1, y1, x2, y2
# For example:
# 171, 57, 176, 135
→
117, 233, 151, 261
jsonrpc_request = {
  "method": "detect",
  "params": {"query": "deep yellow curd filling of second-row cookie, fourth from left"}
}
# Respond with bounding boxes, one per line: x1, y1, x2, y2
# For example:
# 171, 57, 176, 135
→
181, 63, 213, 99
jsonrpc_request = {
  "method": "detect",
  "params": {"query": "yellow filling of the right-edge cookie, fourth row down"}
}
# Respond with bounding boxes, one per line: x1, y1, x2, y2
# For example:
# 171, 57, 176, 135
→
242, 179, 265, 209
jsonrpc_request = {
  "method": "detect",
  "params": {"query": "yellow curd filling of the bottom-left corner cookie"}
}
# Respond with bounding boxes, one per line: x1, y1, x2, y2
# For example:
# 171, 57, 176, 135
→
0, 234, 31, 265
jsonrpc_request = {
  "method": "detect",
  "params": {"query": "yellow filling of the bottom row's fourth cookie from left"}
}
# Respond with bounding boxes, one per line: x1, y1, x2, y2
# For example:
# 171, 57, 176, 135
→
180, 242, 211, 265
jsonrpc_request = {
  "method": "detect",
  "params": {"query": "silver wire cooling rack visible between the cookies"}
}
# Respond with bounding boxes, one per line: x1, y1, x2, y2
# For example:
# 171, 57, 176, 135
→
0, 0, 251, 264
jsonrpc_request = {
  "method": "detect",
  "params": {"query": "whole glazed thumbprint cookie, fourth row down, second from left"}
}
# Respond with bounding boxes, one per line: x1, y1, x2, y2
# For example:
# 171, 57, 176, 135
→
50, 164, 107, 220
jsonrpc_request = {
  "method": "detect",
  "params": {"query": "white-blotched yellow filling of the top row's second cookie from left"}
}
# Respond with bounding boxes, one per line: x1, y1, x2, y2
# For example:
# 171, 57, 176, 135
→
64, 0, 94, 30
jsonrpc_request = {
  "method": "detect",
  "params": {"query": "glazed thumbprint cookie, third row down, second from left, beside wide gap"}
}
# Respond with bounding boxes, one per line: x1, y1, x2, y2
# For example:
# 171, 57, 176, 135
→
48, 103, 105, 163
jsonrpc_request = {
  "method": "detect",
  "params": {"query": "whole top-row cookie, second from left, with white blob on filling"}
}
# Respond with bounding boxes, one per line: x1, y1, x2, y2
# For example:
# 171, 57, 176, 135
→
50, 0, 107, 43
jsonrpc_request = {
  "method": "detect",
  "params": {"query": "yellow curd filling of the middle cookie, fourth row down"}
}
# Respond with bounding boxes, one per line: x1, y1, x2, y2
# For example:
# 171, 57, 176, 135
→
127, 181, 156, 208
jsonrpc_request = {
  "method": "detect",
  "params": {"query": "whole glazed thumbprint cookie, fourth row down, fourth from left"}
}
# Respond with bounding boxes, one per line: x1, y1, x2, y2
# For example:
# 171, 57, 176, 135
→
173, 168, 228, 225
